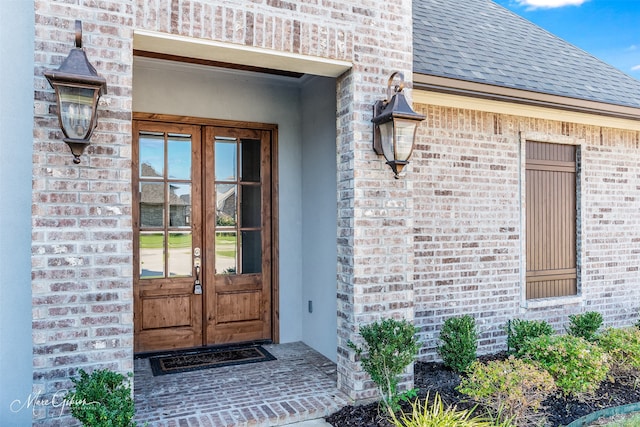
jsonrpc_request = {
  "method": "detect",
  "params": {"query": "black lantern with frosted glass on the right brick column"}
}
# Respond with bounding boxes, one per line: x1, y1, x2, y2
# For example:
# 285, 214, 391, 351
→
371, 71, 426, 178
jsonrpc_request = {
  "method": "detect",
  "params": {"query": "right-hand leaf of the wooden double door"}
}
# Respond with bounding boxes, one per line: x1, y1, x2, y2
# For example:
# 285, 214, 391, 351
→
204, 127, 271, 344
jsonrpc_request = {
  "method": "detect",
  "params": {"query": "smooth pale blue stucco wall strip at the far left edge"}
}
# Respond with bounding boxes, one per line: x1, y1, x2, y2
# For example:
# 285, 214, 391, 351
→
0, 0, 34, 426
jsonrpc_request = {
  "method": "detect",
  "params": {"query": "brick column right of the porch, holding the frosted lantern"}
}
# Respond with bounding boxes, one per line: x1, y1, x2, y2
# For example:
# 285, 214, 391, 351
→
337, 1, 420, 400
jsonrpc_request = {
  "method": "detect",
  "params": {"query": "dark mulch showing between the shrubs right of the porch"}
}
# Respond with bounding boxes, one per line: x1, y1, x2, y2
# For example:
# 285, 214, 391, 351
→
326, 354, 640, 427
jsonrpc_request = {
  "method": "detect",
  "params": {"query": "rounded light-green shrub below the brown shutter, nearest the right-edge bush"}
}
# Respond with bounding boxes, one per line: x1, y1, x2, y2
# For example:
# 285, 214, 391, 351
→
523, 335, 609, 395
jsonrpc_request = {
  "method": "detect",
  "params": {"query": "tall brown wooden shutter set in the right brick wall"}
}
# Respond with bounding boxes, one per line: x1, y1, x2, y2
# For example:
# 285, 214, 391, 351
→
526, 142, 577, 299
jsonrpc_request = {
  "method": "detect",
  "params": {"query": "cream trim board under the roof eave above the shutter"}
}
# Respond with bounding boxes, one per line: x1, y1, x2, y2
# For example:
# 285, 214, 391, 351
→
412, 89, 640, 131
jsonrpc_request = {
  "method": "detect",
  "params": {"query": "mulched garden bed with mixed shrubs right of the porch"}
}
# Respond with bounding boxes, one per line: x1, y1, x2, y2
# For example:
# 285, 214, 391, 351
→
327, 311, 640, 427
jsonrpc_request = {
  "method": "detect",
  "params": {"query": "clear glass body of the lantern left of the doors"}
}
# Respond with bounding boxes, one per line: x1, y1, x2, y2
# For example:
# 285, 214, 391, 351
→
58, 85, 97, 139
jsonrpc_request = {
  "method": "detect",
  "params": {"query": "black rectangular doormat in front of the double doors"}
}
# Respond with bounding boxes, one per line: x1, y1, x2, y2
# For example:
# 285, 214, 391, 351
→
149, 345, 276, 376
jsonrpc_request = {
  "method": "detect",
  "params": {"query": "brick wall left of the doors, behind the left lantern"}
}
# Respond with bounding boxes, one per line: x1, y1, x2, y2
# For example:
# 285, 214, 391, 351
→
32, 0, 133, 425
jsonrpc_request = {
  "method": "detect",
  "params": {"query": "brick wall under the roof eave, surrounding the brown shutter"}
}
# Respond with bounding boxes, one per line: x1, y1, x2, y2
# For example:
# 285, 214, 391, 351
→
408, 105, 640, 359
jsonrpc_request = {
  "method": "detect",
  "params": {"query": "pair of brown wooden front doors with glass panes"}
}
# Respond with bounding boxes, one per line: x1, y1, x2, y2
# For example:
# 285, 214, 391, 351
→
133, 120, 273, 353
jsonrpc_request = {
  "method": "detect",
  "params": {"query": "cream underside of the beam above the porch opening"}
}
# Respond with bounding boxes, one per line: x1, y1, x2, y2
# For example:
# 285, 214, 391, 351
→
133, 30, 352, 77
